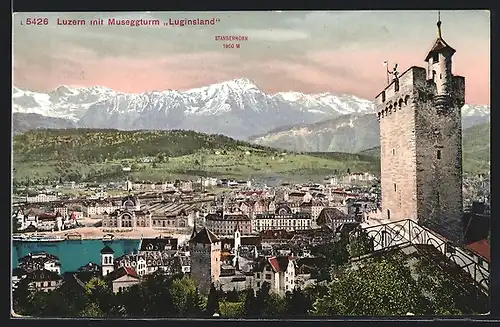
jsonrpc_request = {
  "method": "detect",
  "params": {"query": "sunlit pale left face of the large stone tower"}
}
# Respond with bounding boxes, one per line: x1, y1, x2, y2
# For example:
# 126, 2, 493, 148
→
376, 67, 425, 220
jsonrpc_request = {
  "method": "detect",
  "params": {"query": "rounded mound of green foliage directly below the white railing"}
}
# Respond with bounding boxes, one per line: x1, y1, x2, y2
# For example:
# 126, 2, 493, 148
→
313, 254, 487, 316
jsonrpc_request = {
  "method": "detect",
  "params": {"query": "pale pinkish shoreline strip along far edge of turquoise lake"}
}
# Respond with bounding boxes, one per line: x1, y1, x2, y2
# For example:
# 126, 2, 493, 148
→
15, 227, 190, 244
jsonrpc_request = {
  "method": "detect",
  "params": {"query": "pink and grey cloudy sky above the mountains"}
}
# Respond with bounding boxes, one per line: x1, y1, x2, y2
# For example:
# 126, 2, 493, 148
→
13, 10, 490, 105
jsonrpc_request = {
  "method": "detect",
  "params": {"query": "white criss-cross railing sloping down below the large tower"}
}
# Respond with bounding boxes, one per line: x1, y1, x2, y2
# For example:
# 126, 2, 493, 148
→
363, 219, 490, 292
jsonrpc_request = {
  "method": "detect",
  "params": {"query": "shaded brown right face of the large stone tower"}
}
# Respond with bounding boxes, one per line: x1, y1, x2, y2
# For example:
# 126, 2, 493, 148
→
415, 74, 464, 242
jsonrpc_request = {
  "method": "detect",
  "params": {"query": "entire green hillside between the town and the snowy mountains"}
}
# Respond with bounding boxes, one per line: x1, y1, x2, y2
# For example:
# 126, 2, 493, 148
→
13, 129, 379, 184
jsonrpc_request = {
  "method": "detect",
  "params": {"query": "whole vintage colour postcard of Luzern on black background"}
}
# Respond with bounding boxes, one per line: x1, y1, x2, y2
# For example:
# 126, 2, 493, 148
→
11, 10, 491, 319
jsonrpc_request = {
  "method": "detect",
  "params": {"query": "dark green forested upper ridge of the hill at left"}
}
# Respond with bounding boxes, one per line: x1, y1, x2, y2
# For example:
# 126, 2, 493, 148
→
14, 129, 271, 162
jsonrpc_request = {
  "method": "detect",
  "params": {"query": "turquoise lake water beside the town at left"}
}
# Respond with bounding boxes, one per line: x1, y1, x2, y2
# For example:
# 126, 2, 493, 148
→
12, 240, 140, 273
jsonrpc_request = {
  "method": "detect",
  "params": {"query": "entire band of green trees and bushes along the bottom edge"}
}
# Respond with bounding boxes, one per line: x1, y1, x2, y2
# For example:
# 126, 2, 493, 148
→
13, 253, 489, 318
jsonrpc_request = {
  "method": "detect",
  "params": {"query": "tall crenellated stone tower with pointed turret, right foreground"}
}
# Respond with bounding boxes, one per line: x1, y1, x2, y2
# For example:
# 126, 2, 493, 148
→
376, 14, 465, 243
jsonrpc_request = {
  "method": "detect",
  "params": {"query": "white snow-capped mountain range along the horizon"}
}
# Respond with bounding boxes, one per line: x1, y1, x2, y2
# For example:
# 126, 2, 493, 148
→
12, 78, 489, 139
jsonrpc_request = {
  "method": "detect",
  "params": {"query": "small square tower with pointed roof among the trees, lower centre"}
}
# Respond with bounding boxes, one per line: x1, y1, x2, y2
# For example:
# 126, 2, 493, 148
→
189, 228, 222, 294
